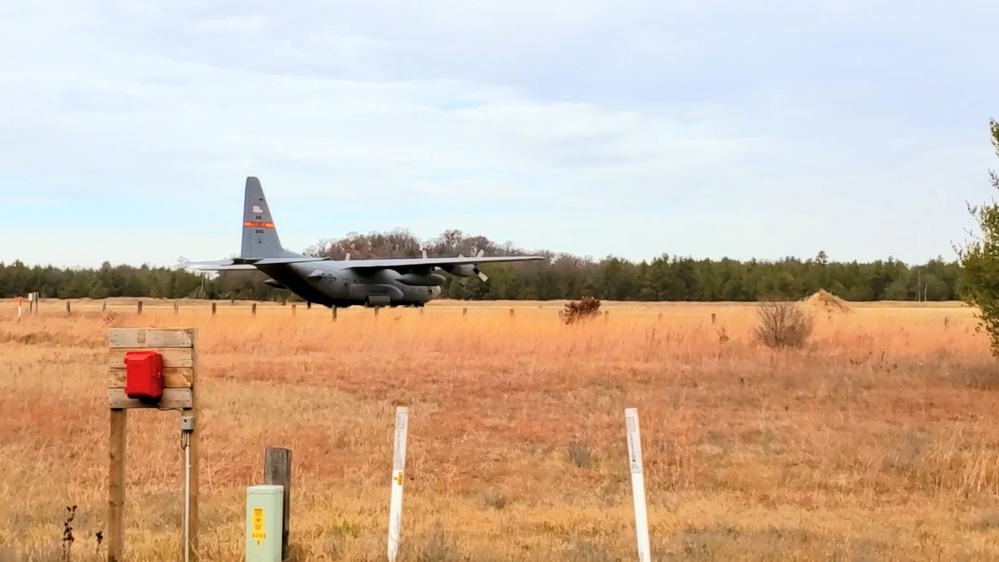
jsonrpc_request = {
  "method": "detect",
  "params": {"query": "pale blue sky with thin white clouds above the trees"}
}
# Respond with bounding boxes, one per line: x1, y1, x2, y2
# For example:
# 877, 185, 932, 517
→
0, 0, 999, 267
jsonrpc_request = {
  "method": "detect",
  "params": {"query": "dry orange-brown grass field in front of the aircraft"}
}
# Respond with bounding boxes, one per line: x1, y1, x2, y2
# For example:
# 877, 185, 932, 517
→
0, 299, 999, 562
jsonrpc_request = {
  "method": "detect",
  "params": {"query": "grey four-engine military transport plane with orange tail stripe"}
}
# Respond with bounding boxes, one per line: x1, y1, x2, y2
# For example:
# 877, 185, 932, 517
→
185, 176, 545, 308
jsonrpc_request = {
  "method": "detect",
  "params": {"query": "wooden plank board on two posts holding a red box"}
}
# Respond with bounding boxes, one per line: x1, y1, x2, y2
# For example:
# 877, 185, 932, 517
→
107, 328, 200, 562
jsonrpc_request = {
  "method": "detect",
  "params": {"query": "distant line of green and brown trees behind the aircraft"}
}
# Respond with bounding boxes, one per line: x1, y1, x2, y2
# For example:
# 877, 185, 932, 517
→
0, 226, 962, 301
